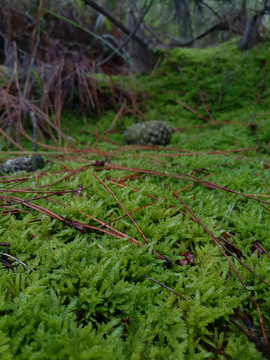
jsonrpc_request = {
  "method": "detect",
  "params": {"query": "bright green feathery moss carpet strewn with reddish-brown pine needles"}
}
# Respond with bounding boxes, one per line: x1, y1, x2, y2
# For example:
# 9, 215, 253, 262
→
0, 42, 270, 360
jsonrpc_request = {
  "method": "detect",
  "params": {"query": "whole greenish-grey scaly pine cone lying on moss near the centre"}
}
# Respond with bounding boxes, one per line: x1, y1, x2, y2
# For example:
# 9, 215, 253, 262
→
124, 120, 172, 145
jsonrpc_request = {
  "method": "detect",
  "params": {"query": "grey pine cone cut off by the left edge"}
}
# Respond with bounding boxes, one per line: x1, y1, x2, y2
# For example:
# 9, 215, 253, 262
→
0, 155, 45, 176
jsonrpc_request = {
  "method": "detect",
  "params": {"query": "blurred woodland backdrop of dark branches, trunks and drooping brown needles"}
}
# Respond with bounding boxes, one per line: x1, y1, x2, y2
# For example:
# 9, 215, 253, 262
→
0, 0, 270, 150
